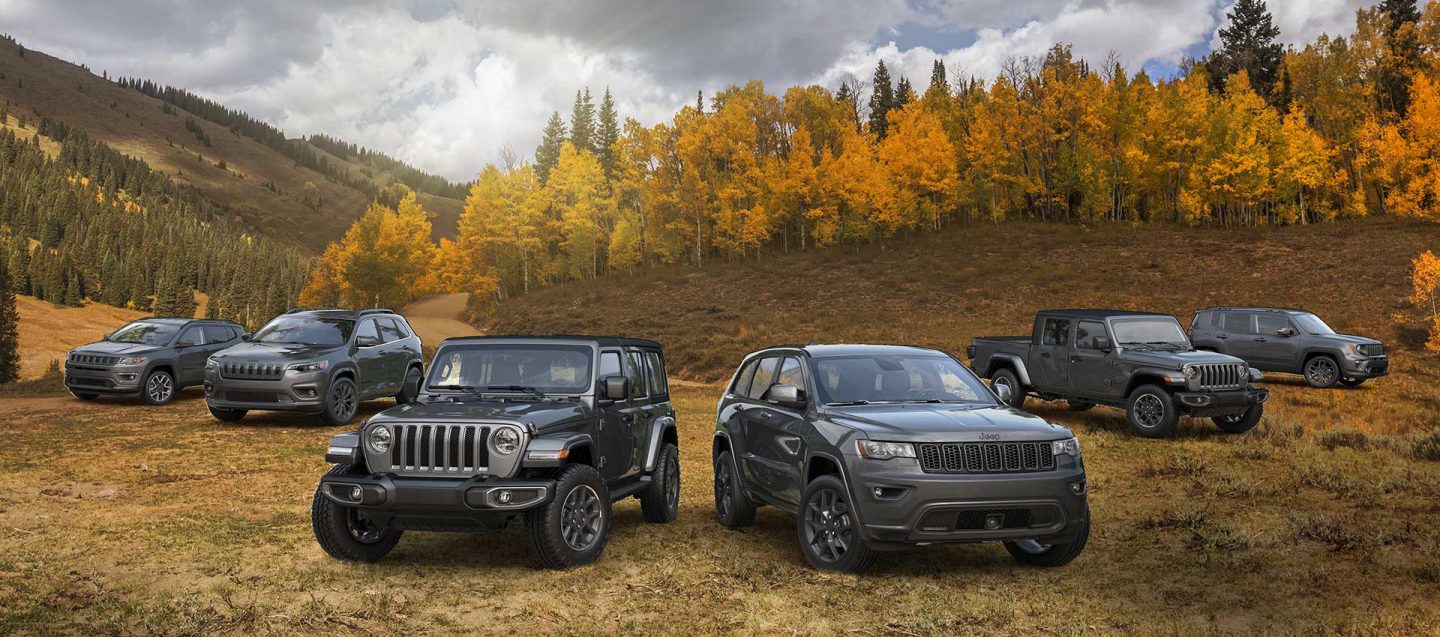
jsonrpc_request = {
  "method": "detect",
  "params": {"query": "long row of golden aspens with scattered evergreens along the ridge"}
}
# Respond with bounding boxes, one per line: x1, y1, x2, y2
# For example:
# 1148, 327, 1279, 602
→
311, 0, 1440, 317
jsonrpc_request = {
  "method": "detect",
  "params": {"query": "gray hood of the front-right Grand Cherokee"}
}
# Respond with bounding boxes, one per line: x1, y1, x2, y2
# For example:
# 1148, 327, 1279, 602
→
825, 404, 1071, 442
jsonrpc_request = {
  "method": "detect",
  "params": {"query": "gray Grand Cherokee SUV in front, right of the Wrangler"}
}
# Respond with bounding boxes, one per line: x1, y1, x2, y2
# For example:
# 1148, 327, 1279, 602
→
713, 344, 1090, 572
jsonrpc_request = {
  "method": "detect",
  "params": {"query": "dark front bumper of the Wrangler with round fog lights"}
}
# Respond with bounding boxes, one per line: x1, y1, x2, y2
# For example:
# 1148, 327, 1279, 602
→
320, 474, 554, 530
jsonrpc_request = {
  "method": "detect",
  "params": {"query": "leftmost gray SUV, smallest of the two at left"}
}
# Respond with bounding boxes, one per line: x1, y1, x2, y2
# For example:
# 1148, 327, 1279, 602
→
65, 319, 245, 405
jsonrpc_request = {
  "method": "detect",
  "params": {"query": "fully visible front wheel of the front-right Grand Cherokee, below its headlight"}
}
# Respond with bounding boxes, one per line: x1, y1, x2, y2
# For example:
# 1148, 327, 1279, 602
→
796, 476, 880, 574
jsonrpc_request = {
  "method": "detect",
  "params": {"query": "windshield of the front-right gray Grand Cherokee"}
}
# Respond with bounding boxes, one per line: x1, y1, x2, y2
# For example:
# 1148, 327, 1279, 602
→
815, 355, 996, 405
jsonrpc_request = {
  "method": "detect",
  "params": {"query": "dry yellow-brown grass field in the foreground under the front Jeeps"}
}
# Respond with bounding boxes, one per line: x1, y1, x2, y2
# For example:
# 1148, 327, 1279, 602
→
0, 386, 1440, 636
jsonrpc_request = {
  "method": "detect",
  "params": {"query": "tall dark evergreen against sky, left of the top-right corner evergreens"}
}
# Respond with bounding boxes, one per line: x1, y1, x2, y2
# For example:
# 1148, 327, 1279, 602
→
1207, 0, 1284, 98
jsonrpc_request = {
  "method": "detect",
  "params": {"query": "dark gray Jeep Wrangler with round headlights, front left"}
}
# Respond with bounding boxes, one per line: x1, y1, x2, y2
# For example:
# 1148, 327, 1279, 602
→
311, 336, 680, 568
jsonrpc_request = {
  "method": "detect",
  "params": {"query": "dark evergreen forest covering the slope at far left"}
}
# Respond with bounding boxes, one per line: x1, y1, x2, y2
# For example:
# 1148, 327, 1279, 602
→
0, 110, 310, 326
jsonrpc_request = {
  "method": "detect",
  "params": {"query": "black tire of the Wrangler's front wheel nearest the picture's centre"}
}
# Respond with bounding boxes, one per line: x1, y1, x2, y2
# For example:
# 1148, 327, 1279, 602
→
526, 464, 612, 568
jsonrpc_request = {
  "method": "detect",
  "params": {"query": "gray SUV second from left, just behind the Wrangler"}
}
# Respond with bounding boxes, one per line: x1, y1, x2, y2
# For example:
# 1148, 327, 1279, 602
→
204, 308, 423, 425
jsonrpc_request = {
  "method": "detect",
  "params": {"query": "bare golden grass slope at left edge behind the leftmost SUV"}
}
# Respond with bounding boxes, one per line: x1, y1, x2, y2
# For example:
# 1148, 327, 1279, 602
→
16, 294, 148, 379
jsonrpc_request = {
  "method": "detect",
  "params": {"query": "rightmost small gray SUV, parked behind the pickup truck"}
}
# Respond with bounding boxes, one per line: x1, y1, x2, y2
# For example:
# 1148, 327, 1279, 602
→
1189, 307, 1390, 388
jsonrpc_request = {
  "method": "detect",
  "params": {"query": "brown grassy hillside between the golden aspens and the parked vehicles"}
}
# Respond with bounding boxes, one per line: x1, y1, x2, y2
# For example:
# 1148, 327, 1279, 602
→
487, 219, 1440, 429
